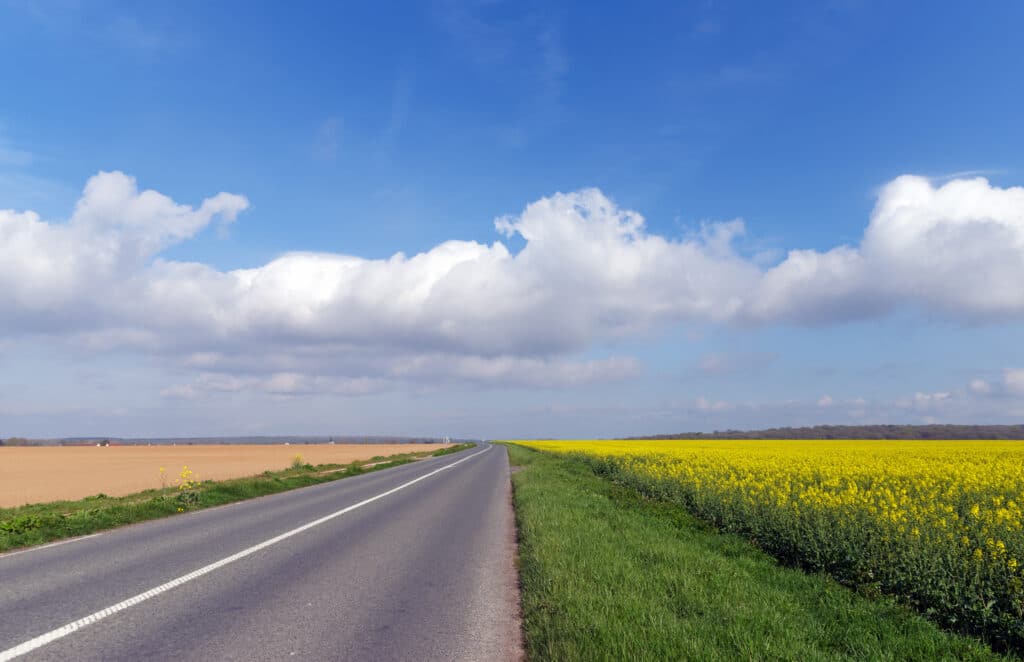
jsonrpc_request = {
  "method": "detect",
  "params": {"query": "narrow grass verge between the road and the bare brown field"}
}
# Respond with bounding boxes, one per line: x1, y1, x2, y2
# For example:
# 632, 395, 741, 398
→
0, 444, 473, 552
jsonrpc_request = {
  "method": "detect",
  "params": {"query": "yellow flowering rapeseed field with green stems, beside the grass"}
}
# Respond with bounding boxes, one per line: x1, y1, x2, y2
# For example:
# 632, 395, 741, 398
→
520, 441, 1024, 650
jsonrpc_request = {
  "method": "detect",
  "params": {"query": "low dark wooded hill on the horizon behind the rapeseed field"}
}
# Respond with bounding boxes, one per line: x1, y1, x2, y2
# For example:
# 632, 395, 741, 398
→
629, 425, 1024, 440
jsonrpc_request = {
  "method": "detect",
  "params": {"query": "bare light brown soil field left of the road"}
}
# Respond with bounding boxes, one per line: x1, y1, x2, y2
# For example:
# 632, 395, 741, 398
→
0, 444, 449, 507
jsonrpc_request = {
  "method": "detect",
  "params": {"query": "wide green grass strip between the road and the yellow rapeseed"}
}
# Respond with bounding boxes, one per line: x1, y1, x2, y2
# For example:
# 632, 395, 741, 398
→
508, 445, 1004, 660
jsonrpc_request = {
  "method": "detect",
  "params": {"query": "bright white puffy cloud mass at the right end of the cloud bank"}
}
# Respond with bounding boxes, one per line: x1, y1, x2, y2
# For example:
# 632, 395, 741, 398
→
749, 175, 1024, 322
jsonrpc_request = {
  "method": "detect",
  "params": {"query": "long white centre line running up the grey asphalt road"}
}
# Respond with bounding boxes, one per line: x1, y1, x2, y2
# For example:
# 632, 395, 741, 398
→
0, 446, 490, 662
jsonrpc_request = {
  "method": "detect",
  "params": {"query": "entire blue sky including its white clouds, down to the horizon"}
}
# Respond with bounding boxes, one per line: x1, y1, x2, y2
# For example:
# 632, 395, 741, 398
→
0, 0, 1024, 438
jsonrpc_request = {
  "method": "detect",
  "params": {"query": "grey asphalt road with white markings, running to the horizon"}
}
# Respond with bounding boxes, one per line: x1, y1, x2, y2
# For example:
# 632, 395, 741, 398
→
0, 445, 520, 662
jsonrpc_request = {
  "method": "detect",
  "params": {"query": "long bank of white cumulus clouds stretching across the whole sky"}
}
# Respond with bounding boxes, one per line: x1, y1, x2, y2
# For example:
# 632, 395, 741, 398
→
0, 172, 1024, 397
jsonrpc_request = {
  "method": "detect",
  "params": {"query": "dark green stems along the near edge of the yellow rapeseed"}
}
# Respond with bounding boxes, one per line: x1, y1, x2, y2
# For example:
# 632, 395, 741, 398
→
573, 454, 1024, 653
